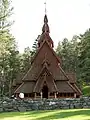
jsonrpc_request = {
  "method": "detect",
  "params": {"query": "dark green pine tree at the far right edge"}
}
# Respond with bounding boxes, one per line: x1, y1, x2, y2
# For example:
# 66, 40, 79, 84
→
79, 29, 90, 83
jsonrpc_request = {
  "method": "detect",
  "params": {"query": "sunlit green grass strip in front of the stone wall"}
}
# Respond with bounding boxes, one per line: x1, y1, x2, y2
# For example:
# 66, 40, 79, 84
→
0, 109, 90, 120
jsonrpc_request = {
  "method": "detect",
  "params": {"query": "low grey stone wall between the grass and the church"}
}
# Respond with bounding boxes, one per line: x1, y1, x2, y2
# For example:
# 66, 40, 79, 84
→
0, 97, 90, 112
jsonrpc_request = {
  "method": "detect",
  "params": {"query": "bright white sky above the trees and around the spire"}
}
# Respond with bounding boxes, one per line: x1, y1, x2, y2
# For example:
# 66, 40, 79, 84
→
11, 0, 90, 52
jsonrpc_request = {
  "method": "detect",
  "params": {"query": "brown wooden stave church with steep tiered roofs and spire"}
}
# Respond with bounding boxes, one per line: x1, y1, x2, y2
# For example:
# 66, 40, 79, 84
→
14, 14, 82, 99
